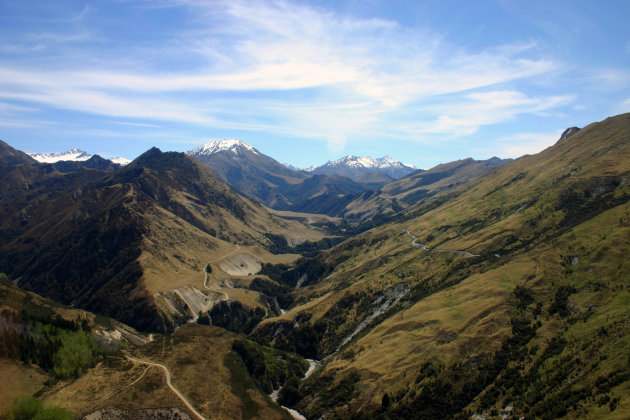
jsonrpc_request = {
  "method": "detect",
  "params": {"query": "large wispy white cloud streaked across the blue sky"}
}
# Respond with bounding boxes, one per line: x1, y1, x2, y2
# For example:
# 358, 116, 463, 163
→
0, 0, 574, 150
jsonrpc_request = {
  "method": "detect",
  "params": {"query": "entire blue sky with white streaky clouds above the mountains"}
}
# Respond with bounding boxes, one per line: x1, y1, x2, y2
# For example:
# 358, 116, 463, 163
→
0, 0, 630, 168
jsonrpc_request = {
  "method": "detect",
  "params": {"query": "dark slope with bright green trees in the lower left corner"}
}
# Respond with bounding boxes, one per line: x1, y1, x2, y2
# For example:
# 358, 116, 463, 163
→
0, 274, 147, 413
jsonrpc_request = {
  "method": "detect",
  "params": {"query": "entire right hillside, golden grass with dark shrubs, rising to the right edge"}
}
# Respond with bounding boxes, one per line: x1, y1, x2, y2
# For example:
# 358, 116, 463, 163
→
252, 114, 630, 419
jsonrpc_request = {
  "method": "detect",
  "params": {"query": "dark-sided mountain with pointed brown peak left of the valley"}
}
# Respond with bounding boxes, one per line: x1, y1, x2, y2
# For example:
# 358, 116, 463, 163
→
0, 146, 323, 330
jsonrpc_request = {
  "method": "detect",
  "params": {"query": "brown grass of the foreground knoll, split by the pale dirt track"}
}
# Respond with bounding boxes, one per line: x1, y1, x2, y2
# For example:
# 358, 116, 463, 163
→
44, 325, 287, 419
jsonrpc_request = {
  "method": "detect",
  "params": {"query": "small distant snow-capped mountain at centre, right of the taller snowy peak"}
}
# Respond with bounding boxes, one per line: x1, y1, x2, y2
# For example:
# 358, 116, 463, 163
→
309, 155, 417, 179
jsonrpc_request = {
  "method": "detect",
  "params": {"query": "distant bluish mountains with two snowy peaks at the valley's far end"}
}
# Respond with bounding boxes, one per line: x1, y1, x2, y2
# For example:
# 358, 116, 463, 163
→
187, 140, 509, 218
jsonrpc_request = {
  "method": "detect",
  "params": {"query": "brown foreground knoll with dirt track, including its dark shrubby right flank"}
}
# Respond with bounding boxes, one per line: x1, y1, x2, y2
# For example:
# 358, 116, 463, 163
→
40, 325, 305, 420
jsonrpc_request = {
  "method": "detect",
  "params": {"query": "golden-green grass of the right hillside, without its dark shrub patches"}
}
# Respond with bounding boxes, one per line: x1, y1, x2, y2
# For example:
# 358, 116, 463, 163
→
253, 115, 630, 418
